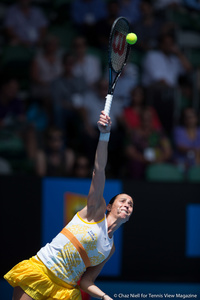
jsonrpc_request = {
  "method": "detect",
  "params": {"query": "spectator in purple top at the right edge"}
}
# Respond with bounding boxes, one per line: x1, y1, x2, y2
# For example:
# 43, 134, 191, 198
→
173, 108, 200, 171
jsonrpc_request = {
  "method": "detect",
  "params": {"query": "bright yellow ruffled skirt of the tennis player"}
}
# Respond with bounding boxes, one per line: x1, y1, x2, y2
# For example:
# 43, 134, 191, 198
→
4, 257, 81, 300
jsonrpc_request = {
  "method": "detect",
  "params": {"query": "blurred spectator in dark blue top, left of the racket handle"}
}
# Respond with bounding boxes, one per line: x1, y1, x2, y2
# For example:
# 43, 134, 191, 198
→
51, 53, 88, 147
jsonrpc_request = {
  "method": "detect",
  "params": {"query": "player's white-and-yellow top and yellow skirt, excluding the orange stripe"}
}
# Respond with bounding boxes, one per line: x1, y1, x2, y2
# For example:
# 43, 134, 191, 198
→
4, 213, 113, 300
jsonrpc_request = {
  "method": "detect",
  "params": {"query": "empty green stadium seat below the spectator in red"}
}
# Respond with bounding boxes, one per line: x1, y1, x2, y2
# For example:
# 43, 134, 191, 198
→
146, 163, 184, 182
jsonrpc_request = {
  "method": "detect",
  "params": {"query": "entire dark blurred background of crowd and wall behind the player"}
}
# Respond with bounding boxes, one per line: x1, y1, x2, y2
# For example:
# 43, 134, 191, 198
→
0, 0, 200, 300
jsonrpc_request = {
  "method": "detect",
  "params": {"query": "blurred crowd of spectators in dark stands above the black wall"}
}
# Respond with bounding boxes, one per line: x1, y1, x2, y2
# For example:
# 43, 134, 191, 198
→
0, 0, 200, 180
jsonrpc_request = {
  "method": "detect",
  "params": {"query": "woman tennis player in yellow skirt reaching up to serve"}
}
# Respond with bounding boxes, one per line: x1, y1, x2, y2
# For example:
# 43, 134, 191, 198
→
4, 111, 133, 300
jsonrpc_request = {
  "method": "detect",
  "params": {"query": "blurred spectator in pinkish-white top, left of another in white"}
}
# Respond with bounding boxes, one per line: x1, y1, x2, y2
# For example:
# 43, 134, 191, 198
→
31, 35, 62, 98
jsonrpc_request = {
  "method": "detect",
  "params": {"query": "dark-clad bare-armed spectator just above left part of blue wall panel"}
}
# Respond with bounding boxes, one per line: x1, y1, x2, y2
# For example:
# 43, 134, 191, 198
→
35, 128, 74, 176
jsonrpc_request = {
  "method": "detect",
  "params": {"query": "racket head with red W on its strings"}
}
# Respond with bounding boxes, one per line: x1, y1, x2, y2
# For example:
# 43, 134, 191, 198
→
108, 17, 130, 73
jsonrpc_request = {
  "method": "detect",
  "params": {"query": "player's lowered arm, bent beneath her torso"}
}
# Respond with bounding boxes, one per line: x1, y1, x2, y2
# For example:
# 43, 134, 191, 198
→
80, 244, 115, 300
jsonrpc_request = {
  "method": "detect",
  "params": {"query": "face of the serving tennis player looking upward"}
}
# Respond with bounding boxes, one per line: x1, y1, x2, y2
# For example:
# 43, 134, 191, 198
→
111, 194, 133, 222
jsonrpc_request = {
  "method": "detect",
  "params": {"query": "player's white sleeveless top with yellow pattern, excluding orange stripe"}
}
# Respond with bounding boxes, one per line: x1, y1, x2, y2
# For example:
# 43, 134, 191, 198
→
37, 213, 113, 286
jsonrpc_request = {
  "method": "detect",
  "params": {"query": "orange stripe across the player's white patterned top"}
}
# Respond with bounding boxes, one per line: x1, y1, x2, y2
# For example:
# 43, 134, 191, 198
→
61, 228, 91, 268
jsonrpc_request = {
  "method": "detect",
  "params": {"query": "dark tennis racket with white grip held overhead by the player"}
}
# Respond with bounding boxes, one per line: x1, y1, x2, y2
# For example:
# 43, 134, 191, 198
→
104, 17, 130, 116
